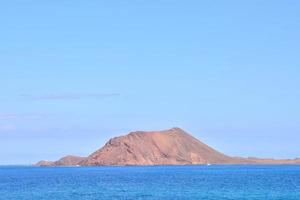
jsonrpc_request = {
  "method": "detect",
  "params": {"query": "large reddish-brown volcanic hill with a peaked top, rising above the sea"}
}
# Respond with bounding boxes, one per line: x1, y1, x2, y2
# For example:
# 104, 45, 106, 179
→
83, 128, 234, 165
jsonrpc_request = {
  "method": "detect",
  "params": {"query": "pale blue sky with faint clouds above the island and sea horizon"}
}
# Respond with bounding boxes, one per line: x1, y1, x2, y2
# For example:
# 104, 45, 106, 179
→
0, 0, 300, 164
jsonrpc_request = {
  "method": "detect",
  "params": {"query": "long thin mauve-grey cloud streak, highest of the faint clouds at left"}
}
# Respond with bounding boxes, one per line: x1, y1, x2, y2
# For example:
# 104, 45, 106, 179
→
21, 93, 120, 100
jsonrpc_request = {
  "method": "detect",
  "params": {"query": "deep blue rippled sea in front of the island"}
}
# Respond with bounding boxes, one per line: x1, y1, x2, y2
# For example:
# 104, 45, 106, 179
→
0, 165, 300, 200
